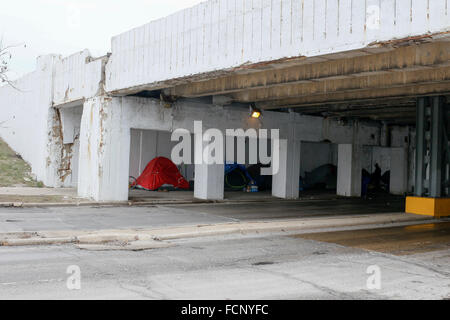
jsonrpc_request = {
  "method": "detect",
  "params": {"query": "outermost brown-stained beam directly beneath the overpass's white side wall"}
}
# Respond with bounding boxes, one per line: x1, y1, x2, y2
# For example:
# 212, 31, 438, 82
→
167, 42, 450, 97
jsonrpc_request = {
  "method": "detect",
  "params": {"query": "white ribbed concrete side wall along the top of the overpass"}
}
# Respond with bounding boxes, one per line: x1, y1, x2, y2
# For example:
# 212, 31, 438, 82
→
106, 0, 450, 91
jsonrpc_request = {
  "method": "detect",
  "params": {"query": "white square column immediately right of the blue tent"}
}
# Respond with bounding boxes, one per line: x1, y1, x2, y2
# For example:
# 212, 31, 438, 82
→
272, 139, 300, 199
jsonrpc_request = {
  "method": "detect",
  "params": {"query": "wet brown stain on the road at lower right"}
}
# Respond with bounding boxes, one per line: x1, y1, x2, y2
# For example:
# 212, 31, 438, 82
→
293, 222, 450, 255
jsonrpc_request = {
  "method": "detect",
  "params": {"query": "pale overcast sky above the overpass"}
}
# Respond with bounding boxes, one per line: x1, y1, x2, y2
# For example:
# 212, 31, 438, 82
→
0, 0, 202, 78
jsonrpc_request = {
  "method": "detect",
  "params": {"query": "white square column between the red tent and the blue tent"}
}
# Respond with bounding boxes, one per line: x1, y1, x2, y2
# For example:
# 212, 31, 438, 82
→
194, 141, 225, 200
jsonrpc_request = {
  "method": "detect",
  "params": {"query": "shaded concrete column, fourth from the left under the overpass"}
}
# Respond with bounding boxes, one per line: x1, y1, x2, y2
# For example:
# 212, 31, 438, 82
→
337, 144, 362, 197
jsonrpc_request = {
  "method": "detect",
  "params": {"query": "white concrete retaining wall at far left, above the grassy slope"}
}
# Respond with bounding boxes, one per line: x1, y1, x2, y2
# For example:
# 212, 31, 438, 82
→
0, 56, 59, 186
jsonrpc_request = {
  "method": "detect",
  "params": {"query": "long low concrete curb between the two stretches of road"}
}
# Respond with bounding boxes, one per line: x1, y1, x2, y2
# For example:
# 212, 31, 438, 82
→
0, 213, 437, 246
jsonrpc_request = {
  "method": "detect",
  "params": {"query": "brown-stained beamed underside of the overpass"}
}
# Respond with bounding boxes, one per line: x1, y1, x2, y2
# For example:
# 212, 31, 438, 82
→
130, 37, 450, 124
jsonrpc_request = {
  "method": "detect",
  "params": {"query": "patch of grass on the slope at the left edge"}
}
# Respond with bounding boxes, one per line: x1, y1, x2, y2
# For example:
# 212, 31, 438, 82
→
0, 139, 42, 187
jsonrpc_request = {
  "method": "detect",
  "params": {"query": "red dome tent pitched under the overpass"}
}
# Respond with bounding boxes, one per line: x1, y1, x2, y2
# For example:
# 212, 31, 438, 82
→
136, 157, 189, 190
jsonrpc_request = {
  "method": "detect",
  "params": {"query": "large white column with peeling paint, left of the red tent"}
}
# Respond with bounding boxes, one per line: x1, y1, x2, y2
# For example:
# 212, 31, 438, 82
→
78, 97, 131, 201
